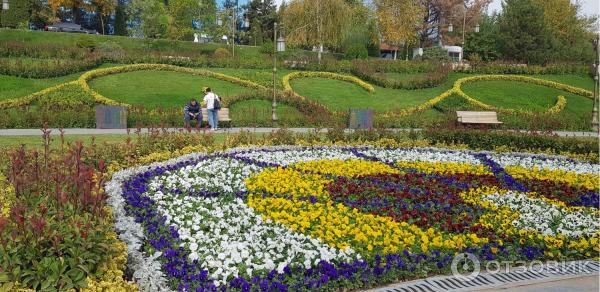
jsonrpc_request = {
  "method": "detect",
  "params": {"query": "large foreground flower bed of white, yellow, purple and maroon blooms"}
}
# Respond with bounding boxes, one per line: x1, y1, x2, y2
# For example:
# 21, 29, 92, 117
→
106, 147, 600, 291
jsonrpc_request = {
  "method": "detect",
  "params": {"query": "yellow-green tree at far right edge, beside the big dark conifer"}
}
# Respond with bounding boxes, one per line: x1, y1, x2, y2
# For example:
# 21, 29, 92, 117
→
533, 0, 596, 61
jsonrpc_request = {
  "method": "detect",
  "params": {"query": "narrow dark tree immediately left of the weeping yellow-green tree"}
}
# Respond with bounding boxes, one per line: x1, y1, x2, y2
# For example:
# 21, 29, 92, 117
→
246, 0, 278, 44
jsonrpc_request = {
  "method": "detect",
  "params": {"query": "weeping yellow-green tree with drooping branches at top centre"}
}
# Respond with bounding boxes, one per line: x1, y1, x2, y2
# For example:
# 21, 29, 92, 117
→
283, 0, 351, 63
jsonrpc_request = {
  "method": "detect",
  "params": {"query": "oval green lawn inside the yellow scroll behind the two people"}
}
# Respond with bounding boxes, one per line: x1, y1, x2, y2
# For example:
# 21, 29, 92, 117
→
90, 71, 250, 107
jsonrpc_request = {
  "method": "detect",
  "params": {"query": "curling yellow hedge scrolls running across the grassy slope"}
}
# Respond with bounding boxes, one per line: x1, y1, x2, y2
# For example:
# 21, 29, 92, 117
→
0, 68, 593, 121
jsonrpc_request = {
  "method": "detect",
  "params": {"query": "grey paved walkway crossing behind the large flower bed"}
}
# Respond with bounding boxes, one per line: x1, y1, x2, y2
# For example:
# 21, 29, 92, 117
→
0, 128, 598, 137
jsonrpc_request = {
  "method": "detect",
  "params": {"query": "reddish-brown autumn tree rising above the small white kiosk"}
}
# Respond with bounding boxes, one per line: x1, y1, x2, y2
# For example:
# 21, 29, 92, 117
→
418, 0, 492, 47
